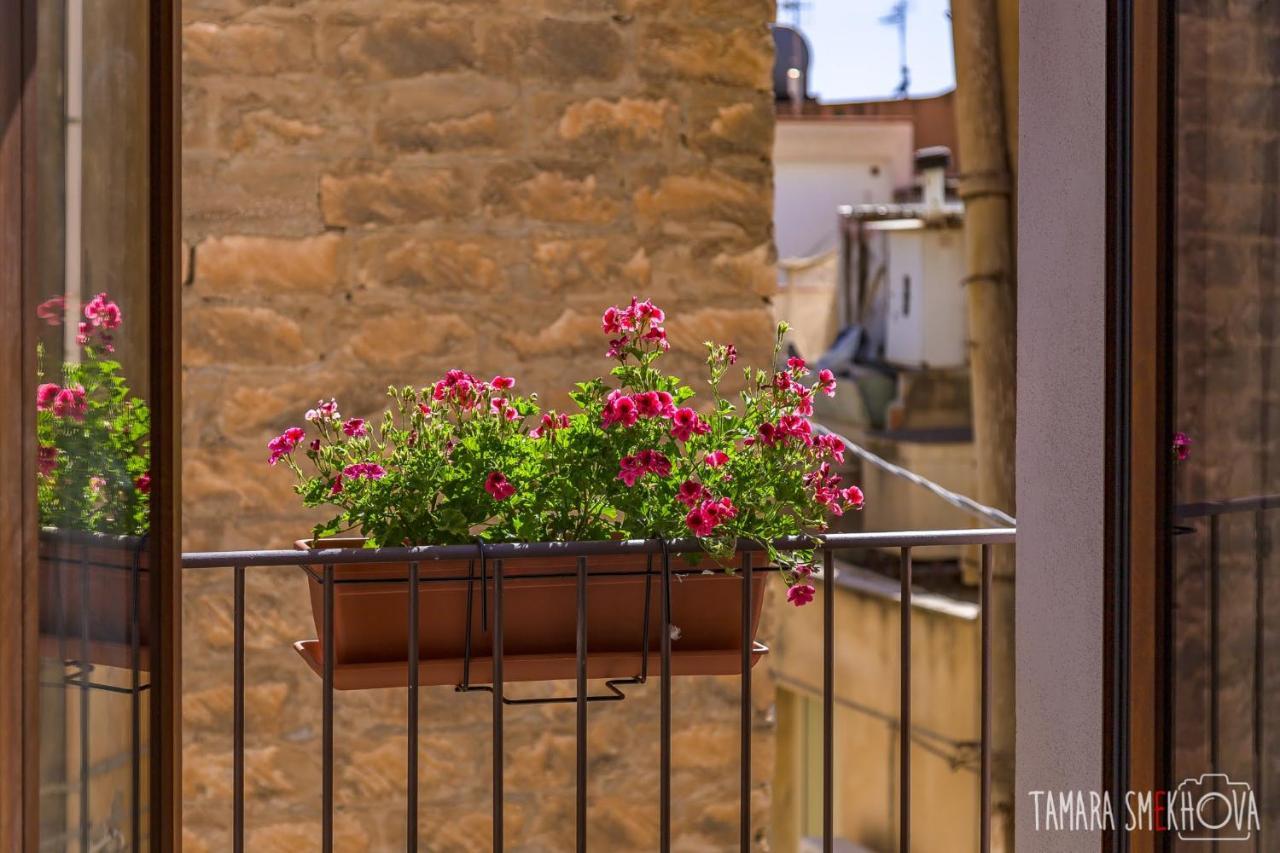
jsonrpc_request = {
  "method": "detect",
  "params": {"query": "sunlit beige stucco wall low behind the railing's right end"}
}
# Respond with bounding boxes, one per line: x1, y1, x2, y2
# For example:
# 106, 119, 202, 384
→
771, 569, 980, 853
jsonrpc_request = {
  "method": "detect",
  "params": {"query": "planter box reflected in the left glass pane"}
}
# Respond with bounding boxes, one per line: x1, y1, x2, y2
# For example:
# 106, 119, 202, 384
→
40, 530, 151, 670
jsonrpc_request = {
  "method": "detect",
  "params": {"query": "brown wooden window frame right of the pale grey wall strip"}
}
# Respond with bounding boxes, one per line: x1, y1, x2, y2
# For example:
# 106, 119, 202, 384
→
1103, 0, 1176, 853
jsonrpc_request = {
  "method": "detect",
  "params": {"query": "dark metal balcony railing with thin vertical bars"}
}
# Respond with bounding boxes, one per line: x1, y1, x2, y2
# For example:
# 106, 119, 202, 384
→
183, 528, 1015, 853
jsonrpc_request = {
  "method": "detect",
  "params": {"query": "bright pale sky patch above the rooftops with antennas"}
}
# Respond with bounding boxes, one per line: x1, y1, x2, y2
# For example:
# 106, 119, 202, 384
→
778, 0, 955, 101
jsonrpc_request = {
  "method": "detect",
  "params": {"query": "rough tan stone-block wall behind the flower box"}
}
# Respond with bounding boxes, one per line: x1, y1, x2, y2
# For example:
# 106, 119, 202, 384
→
183, 0, 773, 852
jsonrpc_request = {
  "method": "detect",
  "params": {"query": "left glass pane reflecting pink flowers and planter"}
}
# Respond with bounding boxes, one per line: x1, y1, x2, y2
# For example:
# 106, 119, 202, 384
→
27, 0, 150, 852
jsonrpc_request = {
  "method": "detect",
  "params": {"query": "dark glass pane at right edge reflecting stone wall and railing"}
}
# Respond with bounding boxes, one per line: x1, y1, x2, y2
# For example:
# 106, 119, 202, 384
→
1171, 0, 1280, 853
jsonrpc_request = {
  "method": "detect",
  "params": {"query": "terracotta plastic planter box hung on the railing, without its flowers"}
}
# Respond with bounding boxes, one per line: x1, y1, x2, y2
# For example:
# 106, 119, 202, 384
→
294, 539, 768, 690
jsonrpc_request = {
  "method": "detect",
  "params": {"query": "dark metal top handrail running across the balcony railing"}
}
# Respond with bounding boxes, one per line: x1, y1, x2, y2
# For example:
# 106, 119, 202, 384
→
182, 528, 1016, 569
